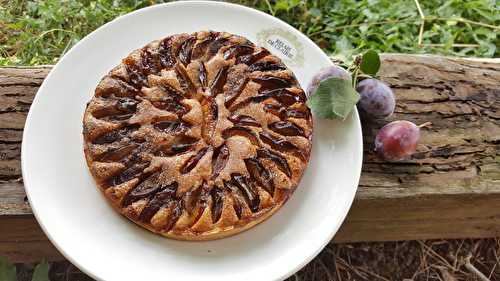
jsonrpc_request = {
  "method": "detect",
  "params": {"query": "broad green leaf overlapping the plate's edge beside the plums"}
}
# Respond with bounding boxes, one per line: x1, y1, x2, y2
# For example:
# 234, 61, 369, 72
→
307, 78, 359, 119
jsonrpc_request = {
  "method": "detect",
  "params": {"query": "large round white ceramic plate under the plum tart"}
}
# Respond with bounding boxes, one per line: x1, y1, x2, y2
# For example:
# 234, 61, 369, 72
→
22, 1, 362, 281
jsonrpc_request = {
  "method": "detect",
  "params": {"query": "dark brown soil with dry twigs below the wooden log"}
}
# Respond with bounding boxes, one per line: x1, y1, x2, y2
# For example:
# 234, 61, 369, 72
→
13, 238, 500, 281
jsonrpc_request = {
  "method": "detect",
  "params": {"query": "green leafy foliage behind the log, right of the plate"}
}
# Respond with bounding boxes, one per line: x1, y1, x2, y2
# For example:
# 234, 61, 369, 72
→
246, 0, 500, 60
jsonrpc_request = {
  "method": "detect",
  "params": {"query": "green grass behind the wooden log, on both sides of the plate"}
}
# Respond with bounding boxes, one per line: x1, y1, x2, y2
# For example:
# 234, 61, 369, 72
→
0, 0, 500, 65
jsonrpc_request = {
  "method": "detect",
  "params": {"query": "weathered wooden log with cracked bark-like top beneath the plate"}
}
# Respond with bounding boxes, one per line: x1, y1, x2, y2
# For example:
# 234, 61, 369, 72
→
0, 55, 500, 261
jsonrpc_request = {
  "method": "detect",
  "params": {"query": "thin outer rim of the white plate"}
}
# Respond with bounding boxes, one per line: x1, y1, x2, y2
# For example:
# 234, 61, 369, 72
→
21, 0, 363, 280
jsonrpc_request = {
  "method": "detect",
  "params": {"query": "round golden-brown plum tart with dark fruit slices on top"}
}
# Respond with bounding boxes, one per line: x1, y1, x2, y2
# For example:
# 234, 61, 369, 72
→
83, 31, 313, 240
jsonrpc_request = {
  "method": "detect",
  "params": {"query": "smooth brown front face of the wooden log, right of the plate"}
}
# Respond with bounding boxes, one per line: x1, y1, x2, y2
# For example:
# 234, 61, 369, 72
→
334, 193, 500, 242
